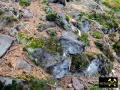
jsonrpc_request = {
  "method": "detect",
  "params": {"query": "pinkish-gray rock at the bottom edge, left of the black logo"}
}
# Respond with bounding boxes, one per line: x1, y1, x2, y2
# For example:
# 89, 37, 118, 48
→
72, 77, 84, 90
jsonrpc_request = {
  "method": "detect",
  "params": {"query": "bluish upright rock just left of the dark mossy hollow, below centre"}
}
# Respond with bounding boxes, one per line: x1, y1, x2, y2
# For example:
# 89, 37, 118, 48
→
52, 57, 71, 78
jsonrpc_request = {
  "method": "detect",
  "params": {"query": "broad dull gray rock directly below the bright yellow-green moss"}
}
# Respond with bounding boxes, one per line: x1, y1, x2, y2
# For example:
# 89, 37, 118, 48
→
28, 48, 61, 69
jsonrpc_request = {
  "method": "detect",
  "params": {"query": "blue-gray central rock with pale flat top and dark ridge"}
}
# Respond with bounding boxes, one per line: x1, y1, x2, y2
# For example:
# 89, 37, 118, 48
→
60, 32, 84, 55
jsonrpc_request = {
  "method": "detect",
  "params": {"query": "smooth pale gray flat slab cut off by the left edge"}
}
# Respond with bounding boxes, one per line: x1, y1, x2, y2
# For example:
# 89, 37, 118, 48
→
0, 34, 13, 57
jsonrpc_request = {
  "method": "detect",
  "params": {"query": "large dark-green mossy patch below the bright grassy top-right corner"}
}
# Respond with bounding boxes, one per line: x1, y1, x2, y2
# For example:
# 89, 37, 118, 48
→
81, 12, 118, 29
